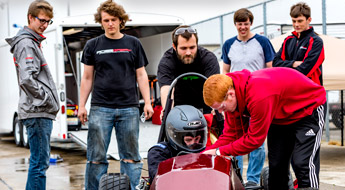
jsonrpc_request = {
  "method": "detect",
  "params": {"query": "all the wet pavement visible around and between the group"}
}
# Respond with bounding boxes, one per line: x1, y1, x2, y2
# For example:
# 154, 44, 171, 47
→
0, 124, 345, 190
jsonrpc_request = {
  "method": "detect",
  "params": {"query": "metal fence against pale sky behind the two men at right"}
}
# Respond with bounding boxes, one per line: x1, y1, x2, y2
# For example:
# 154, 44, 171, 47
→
192, 0, 332, 47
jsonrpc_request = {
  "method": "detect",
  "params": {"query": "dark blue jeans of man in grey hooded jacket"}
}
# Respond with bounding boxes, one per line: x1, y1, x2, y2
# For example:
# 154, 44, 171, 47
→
22, 118, 53, 190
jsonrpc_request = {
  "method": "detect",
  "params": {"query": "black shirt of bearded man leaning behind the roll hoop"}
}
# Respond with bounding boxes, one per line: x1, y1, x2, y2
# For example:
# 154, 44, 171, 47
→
157, 46, 220, 113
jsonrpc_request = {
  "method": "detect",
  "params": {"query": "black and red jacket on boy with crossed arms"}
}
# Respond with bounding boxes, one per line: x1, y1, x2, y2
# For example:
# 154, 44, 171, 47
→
273, 27, 325, 85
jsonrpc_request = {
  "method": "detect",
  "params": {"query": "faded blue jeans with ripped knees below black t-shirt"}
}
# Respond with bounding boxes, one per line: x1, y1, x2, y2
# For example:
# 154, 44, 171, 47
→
85, 106, 142, 190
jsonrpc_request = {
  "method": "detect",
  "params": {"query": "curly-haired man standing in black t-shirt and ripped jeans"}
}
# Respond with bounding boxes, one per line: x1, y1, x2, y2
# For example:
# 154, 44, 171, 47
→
78, 0, 153, 190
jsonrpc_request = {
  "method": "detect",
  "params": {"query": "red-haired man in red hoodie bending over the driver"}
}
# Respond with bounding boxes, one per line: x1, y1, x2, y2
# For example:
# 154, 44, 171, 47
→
203, 68, 326, 190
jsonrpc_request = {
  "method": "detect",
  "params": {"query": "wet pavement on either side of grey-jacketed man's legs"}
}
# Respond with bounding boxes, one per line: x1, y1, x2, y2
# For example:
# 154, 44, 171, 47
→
0, 137, 86, 190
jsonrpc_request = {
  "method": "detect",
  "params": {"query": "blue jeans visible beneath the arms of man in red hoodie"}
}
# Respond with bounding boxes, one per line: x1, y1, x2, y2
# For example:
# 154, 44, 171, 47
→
236, 144, 266, 184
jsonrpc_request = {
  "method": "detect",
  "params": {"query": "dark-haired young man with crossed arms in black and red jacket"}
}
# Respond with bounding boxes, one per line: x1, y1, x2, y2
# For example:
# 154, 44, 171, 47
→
273, 3, 325, 85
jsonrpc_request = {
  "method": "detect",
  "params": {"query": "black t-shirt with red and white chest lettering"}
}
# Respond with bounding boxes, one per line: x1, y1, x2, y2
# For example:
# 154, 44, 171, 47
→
81, 34, 148, 108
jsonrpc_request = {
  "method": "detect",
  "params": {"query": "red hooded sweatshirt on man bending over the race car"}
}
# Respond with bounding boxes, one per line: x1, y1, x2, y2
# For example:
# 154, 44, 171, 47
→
207, 67, 326, 156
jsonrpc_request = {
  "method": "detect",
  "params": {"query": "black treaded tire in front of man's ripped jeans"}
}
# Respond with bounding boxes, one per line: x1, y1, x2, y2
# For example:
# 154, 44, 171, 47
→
98, 173, 131, 190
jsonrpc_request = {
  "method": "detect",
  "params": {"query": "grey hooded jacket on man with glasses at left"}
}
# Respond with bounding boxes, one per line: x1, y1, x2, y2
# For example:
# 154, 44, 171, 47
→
6, 26, 59, 119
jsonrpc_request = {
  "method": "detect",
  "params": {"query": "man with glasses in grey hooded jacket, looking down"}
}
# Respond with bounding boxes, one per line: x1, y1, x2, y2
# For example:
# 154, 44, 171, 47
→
6, 0, 59, 190
